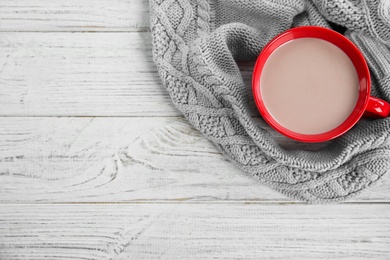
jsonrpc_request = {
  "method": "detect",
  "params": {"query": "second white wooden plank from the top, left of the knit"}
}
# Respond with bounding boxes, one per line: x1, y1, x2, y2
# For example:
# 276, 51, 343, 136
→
0, 33, 258, 116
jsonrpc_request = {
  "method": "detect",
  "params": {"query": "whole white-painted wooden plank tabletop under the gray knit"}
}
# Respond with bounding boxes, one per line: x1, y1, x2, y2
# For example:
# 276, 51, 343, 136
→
0, 0, 390, 260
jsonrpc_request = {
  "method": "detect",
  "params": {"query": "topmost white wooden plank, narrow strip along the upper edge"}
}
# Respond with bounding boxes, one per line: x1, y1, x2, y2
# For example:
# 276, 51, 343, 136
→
0, 0, 149, 32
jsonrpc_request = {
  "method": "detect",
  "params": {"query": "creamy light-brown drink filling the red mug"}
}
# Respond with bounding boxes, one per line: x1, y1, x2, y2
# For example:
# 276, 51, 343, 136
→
260, 38, 359, 134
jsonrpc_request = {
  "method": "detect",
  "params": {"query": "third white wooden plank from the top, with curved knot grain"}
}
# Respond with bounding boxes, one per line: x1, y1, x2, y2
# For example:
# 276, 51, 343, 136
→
0, 117, 390, 203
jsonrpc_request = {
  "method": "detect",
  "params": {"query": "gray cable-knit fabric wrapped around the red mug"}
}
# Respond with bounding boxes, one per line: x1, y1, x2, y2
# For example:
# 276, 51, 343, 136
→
150, 0, 390, 203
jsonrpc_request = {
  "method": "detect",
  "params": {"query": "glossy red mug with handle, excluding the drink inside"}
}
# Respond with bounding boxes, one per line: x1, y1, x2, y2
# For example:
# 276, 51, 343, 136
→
252, 26, 390, 142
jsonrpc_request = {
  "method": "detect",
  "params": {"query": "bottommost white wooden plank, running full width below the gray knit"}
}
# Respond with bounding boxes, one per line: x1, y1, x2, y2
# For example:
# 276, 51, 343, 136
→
0, 203, 390, 260
